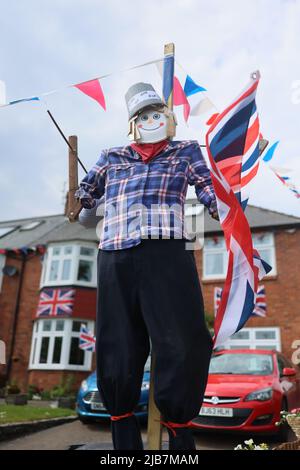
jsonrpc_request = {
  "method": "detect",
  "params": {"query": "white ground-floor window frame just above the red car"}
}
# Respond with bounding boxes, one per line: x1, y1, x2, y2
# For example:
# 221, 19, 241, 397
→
220, 326, 281, 352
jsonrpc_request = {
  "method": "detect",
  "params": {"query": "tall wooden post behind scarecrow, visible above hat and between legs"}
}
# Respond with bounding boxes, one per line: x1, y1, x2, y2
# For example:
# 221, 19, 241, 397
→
147, 43, 175, 450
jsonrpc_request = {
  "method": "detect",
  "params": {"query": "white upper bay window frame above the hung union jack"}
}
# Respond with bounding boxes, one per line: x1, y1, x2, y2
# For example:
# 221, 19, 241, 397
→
40, 242, 98, 288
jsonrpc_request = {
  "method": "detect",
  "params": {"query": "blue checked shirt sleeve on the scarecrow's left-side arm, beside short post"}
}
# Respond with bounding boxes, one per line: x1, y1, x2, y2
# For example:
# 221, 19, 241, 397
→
75, 150, 108, 209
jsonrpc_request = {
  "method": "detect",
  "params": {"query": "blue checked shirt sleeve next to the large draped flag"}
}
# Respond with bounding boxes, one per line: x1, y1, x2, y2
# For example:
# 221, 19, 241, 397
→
188, 141, 217, 214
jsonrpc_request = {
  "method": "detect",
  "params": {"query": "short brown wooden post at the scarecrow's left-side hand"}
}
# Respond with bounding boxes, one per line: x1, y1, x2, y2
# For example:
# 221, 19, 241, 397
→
65, 135, 82, 222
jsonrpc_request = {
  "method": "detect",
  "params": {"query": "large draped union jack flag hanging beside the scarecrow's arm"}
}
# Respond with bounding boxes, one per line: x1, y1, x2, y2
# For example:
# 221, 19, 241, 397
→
206, 72, 271, 347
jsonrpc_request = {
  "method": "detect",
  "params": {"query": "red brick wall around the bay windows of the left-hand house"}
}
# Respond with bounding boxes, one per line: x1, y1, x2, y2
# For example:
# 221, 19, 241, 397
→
0, 256, 96, 391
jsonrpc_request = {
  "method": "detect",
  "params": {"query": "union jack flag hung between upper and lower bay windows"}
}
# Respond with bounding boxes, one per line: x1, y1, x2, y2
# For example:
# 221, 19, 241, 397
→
36, 288, 75, 317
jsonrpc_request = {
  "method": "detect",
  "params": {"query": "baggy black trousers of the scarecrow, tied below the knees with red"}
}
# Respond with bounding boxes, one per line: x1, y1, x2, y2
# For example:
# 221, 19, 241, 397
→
96, 239, 212, 423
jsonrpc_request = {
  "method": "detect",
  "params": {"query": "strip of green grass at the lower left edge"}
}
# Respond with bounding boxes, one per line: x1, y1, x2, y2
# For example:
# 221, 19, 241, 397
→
0, 405, 76, 425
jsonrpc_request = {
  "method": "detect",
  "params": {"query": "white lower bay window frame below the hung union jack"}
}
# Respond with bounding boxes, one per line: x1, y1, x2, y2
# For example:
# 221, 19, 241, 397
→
28, 317, 95, 371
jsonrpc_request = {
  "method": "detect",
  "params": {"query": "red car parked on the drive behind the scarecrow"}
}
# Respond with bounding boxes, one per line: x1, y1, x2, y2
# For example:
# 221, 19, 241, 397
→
193, 349, 300, 437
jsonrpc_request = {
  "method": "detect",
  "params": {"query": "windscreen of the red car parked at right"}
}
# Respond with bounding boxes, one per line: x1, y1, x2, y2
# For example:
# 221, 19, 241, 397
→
209, 353, 273, 375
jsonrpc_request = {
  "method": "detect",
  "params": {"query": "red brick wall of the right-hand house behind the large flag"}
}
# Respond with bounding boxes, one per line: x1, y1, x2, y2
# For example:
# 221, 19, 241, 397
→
195, 230, 300, 358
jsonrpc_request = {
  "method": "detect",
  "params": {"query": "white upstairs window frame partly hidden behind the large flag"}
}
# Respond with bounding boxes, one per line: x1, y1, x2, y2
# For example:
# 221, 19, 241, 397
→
202, 231, 277, 281
